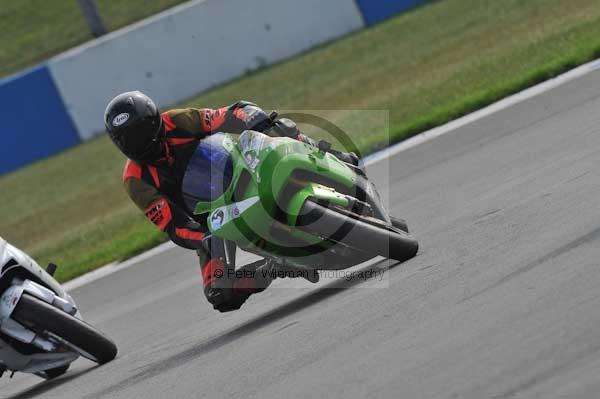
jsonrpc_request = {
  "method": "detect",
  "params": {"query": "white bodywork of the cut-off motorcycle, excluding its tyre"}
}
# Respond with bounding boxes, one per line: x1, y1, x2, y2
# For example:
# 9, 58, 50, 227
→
0, 237, 81, 373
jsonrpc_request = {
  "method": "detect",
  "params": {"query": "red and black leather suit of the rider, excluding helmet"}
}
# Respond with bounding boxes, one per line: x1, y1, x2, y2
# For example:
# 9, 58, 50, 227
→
123, 101, 314, 312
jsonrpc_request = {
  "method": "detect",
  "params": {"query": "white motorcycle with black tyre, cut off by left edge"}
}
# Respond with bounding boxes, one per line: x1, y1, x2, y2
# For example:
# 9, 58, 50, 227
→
0, 237, 117, 379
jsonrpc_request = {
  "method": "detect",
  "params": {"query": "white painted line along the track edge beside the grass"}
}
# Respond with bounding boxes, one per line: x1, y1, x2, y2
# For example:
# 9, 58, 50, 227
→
63, 59, 600, 291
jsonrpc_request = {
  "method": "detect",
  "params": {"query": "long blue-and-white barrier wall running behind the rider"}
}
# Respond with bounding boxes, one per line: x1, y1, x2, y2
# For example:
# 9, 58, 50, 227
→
0, 0, 428, 175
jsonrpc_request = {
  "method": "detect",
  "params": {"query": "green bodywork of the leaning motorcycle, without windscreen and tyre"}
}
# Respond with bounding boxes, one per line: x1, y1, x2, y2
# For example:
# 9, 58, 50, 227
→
194, 131, 356, 265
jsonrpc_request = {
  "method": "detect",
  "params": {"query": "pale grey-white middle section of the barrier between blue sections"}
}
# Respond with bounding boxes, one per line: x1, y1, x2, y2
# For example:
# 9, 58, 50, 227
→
48, 0, 364, 139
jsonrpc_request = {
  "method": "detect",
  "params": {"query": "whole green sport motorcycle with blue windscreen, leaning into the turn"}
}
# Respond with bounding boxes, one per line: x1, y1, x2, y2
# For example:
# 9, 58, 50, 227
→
182, 131, 418, 270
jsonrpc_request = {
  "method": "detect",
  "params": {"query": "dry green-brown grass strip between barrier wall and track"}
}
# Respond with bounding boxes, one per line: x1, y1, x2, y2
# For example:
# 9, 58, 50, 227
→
0, 0, 600, 280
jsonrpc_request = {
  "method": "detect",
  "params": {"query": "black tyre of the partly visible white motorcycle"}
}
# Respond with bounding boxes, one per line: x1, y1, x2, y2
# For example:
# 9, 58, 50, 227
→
11, 294, 117, 371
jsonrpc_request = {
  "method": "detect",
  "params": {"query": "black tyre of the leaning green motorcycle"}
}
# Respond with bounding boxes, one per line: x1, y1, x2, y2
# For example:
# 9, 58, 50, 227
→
297, 201, 419, 262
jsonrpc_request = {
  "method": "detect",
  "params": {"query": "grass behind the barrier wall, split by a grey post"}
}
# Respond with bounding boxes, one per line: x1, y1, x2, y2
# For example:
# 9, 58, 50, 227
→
0, 0, 185, 77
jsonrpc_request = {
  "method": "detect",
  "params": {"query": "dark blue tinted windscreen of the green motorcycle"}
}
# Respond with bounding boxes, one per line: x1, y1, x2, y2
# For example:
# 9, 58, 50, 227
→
182, 133, 233, 211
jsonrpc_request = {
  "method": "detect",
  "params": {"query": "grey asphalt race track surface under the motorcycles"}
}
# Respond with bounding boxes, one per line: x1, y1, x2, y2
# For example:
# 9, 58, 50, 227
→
0, 72, 600, 399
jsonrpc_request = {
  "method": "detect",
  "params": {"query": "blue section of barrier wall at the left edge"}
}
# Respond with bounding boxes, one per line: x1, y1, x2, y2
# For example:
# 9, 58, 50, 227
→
0, 65, 80, 174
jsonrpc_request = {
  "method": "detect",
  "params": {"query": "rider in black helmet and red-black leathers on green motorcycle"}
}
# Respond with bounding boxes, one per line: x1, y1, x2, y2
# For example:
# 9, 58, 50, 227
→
104, 91, 358, 312
